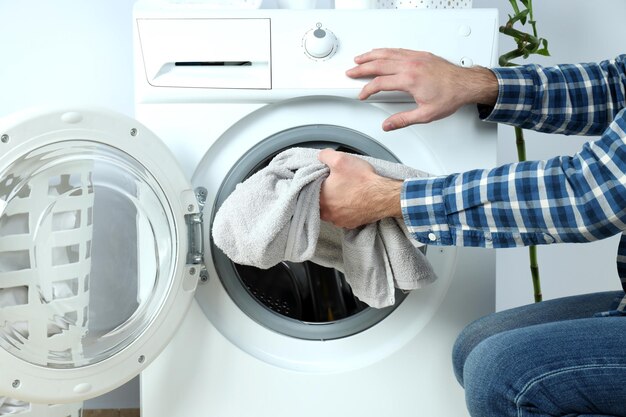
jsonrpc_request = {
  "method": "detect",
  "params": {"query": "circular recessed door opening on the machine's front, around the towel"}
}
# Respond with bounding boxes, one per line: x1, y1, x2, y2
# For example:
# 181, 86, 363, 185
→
192, 96, 458, 373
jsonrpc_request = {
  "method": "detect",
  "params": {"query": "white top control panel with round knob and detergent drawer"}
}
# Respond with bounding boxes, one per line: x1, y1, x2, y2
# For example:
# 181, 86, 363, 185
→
135, 7, 498, 101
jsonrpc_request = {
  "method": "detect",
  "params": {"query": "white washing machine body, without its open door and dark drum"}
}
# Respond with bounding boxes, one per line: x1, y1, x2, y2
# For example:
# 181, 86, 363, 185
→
134, 3, 497, 417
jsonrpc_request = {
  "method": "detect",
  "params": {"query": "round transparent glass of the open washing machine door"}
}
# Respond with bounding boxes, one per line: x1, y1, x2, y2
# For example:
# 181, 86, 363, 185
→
0, 140, 178, 368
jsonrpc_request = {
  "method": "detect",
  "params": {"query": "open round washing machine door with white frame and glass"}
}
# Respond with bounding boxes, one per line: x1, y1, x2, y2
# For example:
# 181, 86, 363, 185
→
0, 110, 197, 403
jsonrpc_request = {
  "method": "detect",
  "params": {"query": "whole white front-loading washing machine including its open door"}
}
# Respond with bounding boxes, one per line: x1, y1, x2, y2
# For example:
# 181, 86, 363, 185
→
0, 2, 497, 417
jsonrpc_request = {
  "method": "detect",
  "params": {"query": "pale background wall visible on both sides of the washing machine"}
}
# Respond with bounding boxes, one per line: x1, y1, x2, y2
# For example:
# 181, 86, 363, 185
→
0, 0, 626, 408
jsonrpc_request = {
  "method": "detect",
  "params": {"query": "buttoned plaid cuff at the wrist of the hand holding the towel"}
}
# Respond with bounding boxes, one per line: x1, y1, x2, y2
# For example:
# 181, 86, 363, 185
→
400, 177, 454, 245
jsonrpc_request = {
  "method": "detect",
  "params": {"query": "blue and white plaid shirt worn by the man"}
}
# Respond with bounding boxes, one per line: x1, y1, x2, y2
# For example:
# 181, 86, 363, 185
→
402, 55, 626, 315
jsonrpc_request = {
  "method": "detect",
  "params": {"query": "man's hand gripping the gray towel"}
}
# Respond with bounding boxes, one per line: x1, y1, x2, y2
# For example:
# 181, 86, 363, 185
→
318, 149, 402, 229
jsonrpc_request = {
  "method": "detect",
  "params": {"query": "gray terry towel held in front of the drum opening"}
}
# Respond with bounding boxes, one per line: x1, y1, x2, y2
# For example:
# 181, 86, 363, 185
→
213, 148, 436, 308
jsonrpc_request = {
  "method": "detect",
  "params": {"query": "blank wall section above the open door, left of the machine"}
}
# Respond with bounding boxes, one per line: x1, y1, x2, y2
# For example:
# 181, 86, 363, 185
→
0, 0, 134, 115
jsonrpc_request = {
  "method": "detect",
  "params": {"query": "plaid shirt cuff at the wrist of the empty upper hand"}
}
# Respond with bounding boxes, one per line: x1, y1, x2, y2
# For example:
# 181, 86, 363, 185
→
478, 65, 537, 125
